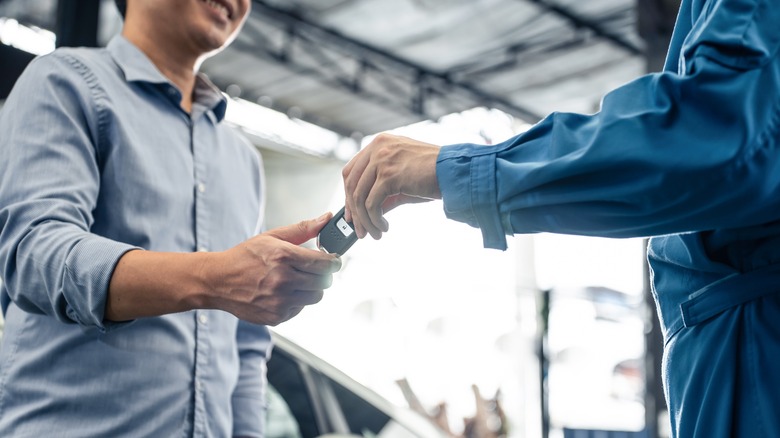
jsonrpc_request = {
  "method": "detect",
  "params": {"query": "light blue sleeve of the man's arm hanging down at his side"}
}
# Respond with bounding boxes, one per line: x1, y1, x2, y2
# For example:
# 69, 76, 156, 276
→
232, 321, 272, 437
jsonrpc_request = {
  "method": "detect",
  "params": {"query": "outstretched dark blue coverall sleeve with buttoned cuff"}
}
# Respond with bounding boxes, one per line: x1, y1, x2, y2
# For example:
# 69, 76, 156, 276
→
436, 0, 780, 249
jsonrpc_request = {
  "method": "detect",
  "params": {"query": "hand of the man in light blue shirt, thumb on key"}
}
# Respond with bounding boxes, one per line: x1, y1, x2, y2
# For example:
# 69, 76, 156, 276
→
210, 213, 341, 326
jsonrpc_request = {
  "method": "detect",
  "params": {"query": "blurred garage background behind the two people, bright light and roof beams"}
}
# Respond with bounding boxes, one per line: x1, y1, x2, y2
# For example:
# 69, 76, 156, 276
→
0, 0, 678, 438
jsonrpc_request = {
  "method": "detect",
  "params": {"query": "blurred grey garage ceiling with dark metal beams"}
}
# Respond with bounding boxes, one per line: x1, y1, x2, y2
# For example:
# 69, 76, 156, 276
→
0, 0, 660, 137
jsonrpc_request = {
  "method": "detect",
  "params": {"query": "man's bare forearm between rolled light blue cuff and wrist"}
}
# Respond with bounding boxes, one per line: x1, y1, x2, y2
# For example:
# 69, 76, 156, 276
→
105, 250, 214, 321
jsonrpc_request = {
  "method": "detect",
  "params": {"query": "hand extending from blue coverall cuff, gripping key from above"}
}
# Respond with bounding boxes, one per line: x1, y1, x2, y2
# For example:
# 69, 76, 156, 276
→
342, 134, 441, 239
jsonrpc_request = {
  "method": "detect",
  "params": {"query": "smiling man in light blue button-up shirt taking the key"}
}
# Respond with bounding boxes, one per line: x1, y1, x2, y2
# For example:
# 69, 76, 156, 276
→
0, 0, 340, 437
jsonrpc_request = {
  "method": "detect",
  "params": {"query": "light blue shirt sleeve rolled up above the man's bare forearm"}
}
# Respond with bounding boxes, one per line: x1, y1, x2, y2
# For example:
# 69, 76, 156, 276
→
0, 52, 133, 330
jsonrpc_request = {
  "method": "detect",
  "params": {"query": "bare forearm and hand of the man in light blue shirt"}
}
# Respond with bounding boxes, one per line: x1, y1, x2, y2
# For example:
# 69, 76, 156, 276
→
105, 213, 341, 325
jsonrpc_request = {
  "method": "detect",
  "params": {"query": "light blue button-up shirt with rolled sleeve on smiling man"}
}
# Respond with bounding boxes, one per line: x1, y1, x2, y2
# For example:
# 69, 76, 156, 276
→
0, 36, 270, 437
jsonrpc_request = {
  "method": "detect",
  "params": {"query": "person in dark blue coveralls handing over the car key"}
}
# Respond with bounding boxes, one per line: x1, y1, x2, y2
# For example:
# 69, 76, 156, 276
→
343, 0, 780, 438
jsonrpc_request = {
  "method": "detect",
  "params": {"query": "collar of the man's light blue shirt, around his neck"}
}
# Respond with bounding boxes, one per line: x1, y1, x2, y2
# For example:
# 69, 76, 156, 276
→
107, 35, 227, 121
